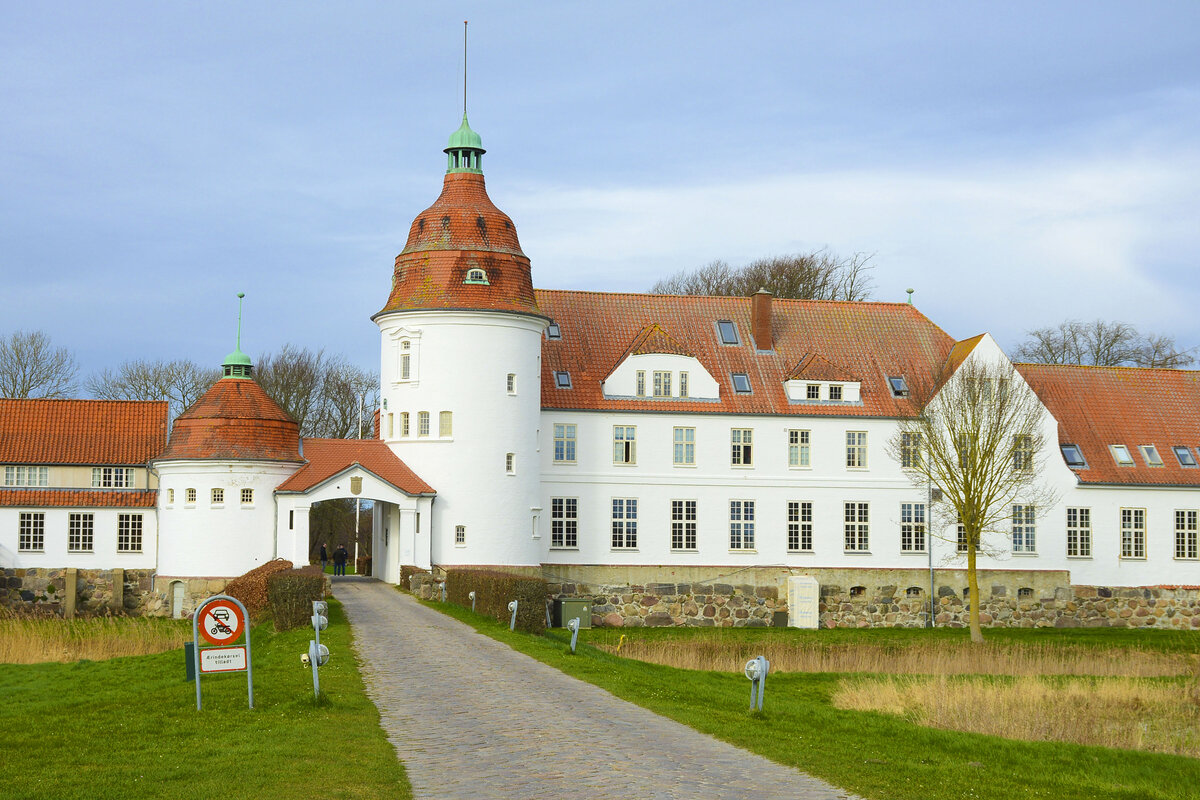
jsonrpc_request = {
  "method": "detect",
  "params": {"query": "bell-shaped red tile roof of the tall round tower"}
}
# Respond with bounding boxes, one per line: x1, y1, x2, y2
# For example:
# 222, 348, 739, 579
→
379, 173, 538, 314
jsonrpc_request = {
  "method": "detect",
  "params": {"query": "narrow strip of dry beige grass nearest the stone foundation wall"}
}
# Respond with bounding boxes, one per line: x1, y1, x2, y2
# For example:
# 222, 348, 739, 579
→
606, 639, 1190, 678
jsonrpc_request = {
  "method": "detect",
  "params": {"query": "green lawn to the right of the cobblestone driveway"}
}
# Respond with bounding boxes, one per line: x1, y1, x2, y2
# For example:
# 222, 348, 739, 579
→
428, 603, 1200, 800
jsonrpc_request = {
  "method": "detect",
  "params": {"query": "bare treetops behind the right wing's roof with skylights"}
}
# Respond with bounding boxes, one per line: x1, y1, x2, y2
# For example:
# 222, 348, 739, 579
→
1014, 319, 1194, 368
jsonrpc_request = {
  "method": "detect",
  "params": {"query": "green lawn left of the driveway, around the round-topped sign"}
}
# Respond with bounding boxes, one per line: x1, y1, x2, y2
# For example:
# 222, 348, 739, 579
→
0, 602, 412, 800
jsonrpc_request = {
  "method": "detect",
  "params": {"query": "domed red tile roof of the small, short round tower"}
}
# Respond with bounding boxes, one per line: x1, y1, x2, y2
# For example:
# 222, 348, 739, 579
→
158, 378, 304, 462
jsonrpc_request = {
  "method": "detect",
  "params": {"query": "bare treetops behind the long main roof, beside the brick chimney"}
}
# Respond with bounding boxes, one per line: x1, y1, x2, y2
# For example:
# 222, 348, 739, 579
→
650, 251, 872, 300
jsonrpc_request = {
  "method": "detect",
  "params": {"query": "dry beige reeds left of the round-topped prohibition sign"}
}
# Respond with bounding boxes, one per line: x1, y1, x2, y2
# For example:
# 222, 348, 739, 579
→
0, 616, 191, 664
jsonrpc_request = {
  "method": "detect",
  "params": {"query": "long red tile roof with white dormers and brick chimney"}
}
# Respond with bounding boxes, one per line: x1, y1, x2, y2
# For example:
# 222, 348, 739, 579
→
536, 290, 954, 417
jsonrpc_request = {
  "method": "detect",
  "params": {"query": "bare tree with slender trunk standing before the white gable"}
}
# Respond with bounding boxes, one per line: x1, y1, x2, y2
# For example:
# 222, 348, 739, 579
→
888, 359, 1056, 642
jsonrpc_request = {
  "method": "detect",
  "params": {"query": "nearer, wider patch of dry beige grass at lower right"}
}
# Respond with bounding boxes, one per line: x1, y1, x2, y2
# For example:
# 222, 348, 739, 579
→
833, 675, 1200, 758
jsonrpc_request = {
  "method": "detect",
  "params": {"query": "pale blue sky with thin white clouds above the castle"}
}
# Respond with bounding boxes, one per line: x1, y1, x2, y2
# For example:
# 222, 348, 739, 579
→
0, 0, 1200, 374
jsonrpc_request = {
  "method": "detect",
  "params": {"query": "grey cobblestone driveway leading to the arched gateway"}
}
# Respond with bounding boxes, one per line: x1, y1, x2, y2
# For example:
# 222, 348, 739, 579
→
334, 578, 853, 800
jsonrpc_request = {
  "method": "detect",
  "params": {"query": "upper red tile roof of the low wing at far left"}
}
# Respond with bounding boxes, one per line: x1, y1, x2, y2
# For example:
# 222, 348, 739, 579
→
0, 399, 167, 465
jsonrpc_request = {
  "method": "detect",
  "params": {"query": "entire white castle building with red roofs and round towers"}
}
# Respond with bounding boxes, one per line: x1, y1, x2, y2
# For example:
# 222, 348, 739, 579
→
0, 118, 1200, 627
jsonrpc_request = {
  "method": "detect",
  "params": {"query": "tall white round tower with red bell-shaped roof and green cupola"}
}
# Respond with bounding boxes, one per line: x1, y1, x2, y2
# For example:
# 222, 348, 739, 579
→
372, 114, 547, 566
